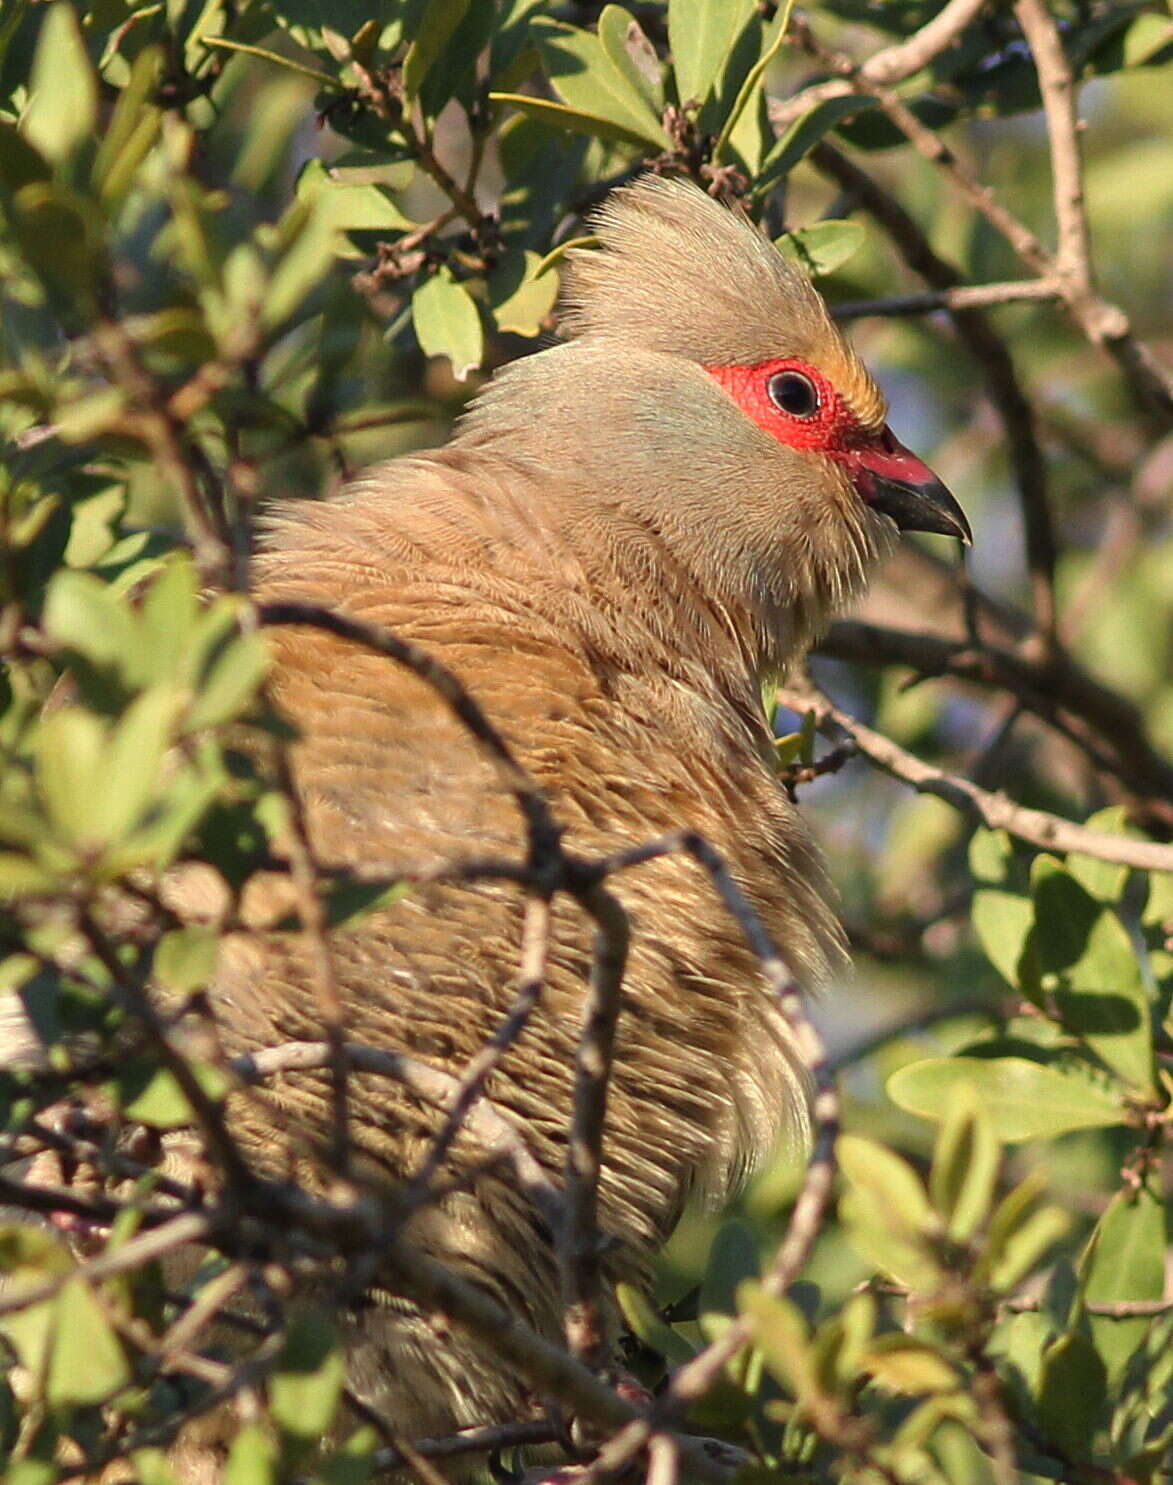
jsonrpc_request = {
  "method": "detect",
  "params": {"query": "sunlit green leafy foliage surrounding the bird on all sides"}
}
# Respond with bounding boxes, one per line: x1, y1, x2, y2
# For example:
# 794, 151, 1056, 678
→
0, 0, 1173, 1485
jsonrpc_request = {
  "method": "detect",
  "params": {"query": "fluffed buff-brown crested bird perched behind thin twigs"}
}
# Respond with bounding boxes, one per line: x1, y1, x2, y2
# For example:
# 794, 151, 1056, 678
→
188, 175, 970, 1461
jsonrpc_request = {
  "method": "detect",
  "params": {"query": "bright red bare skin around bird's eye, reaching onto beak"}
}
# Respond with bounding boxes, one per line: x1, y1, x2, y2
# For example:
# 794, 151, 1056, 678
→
705, 356, 937, 502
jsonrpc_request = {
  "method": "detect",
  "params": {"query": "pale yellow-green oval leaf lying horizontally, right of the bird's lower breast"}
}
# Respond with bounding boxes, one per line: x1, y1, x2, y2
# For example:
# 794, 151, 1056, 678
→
888, 1057, 1128, 1142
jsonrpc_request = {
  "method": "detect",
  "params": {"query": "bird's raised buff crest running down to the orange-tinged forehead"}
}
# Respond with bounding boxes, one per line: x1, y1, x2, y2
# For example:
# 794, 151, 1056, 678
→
563, 175, 885, 428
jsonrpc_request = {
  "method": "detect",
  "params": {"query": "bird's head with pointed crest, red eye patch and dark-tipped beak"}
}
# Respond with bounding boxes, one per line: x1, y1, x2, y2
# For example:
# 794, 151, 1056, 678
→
457, 175, 970, 653
